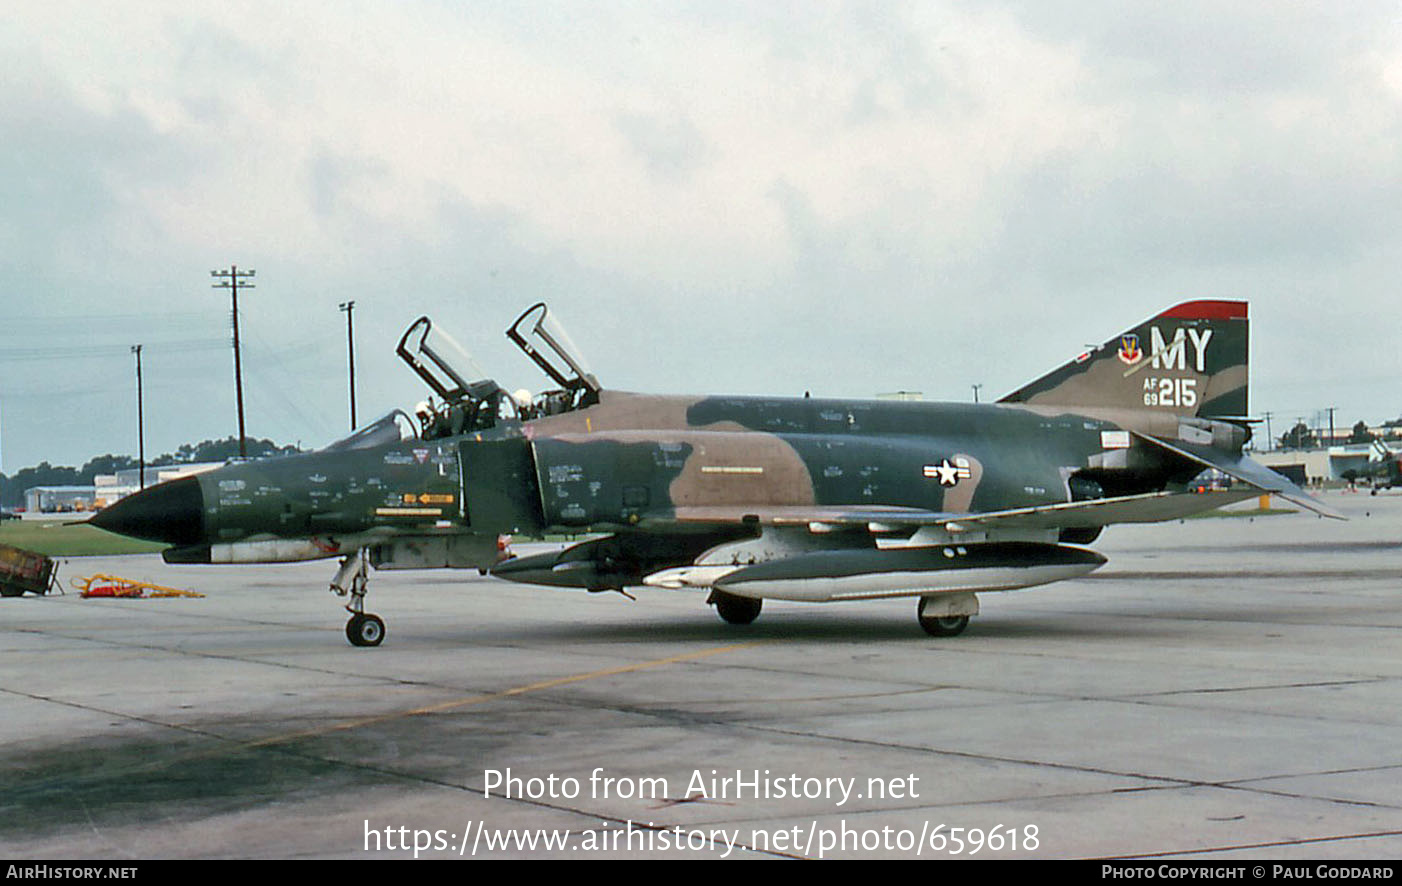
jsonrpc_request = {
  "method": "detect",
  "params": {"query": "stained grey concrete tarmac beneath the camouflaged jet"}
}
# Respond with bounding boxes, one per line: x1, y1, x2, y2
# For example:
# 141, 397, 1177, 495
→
0, 493, 1402, 861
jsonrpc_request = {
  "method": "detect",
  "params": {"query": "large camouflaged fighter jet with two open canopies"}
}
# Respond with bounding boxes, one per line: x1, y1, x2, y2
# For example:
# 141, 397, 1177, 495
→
93, 301, 1339, 646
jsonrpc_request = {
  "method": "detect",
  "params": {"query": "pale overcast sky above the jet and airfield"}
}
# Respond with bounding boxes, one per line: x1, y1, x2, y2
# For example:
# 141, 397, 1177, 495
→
0, 0, 1402, 474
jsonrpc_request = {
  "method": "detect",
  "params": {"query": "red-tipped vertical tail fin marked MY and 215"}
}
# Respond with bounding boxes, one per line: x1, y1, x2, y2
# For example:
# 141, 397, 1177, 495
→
998, 301, 1248, 418
